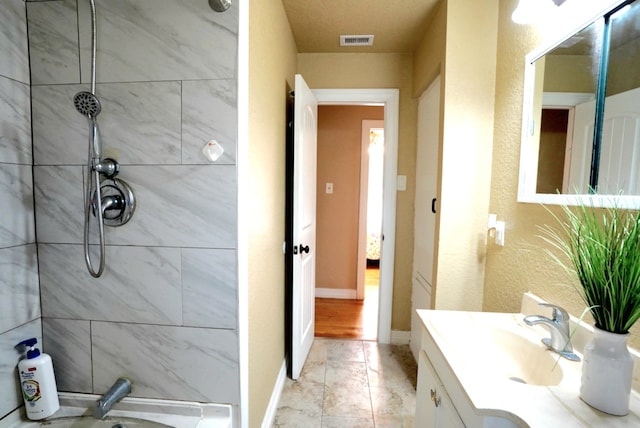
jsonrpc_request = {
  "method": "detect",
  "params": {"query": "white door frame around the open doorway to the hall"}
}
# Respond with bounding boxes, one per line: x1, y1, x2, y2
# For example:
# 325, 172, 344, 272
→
312, 89, 400, 343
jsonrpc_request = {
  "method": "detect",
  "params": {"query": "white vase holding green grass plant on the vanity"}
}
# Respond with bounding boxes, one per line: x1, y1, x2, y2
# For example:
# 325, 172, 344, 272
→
580, 327, 633, 416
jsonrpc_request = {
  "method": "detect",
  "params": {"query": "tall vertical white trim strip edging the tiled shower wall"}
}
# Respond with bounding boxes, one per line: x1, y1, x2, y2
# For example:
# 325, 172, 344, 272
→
233, 1, 246, 428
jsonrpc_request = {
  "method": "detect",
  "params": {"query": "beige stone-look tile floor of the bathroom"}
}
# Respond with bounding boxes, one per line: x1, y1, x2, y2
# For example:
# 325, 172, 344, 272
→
273, 338, 418, 428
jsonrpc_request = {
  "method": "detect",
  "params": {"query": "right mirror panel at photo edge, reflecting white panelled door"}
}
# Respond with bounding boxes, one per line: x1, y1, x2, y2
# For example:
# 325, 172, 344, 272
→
598, 1, 640, 195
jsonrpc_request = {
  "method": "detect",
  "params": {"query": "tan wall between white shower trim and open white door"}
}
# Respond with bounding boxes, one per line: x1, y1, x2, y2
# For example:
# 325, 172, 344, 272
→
245, 0, 297, 427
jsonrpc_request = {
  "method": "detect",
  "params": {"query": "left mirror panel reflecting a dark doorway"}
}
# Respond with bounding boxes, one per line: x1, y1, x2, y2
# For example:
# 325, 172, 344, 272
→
534, 19, 603, 194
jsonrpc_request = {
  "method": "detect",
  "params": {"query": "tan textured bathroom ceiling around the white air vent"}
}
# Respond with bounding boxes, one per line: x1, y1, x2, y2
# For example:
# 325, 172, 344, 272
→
282, 0, 440, 53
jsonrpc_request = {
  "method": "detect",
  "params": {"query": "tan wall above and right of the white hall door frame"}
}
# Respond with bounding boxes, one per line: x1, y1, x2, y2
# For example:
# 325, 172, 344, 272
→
298, 53, 418, 331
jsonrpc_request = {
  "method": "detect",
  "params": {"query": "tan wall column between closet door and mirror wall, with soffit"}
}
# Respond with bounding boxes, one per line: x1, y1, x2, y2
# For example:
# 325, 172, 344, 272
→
414, 0, 498, 310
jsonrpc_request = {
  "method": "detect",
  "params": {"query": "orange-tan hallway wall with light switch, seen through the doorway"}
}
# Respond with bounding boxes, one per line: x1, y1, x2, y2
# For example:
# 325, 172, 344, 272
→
316, 105, 384, 290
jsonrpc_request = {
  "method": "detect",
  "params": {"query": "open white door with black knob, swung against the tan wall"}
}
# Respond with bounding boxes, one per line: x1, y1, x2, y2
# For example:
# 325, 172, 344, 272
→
291, 74, 318, 379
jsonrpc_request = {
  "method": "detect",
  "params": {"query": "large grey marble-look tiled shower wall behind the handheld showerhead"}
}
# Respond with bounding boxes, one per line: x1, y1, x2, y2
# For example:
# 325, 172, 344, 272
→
26, 0, 239, 405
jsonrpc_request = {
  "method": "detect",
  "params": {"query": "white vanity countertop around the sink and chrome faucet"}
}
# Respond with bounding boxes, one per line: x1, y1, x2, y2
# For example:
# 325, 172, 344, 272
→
418, 310, 640, 428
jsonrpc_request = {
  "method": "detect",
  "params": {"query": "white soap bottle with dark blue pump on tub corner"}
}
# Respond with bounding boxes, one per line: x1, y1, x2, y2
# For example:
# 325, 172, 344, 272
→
16, 338, 60, 420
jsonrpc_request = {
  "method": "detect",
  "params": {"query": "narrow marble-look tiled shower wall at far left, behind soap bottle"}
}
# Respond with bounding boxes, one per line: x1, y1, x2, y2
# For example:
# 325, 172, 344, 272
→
0, 0, 42, 418
